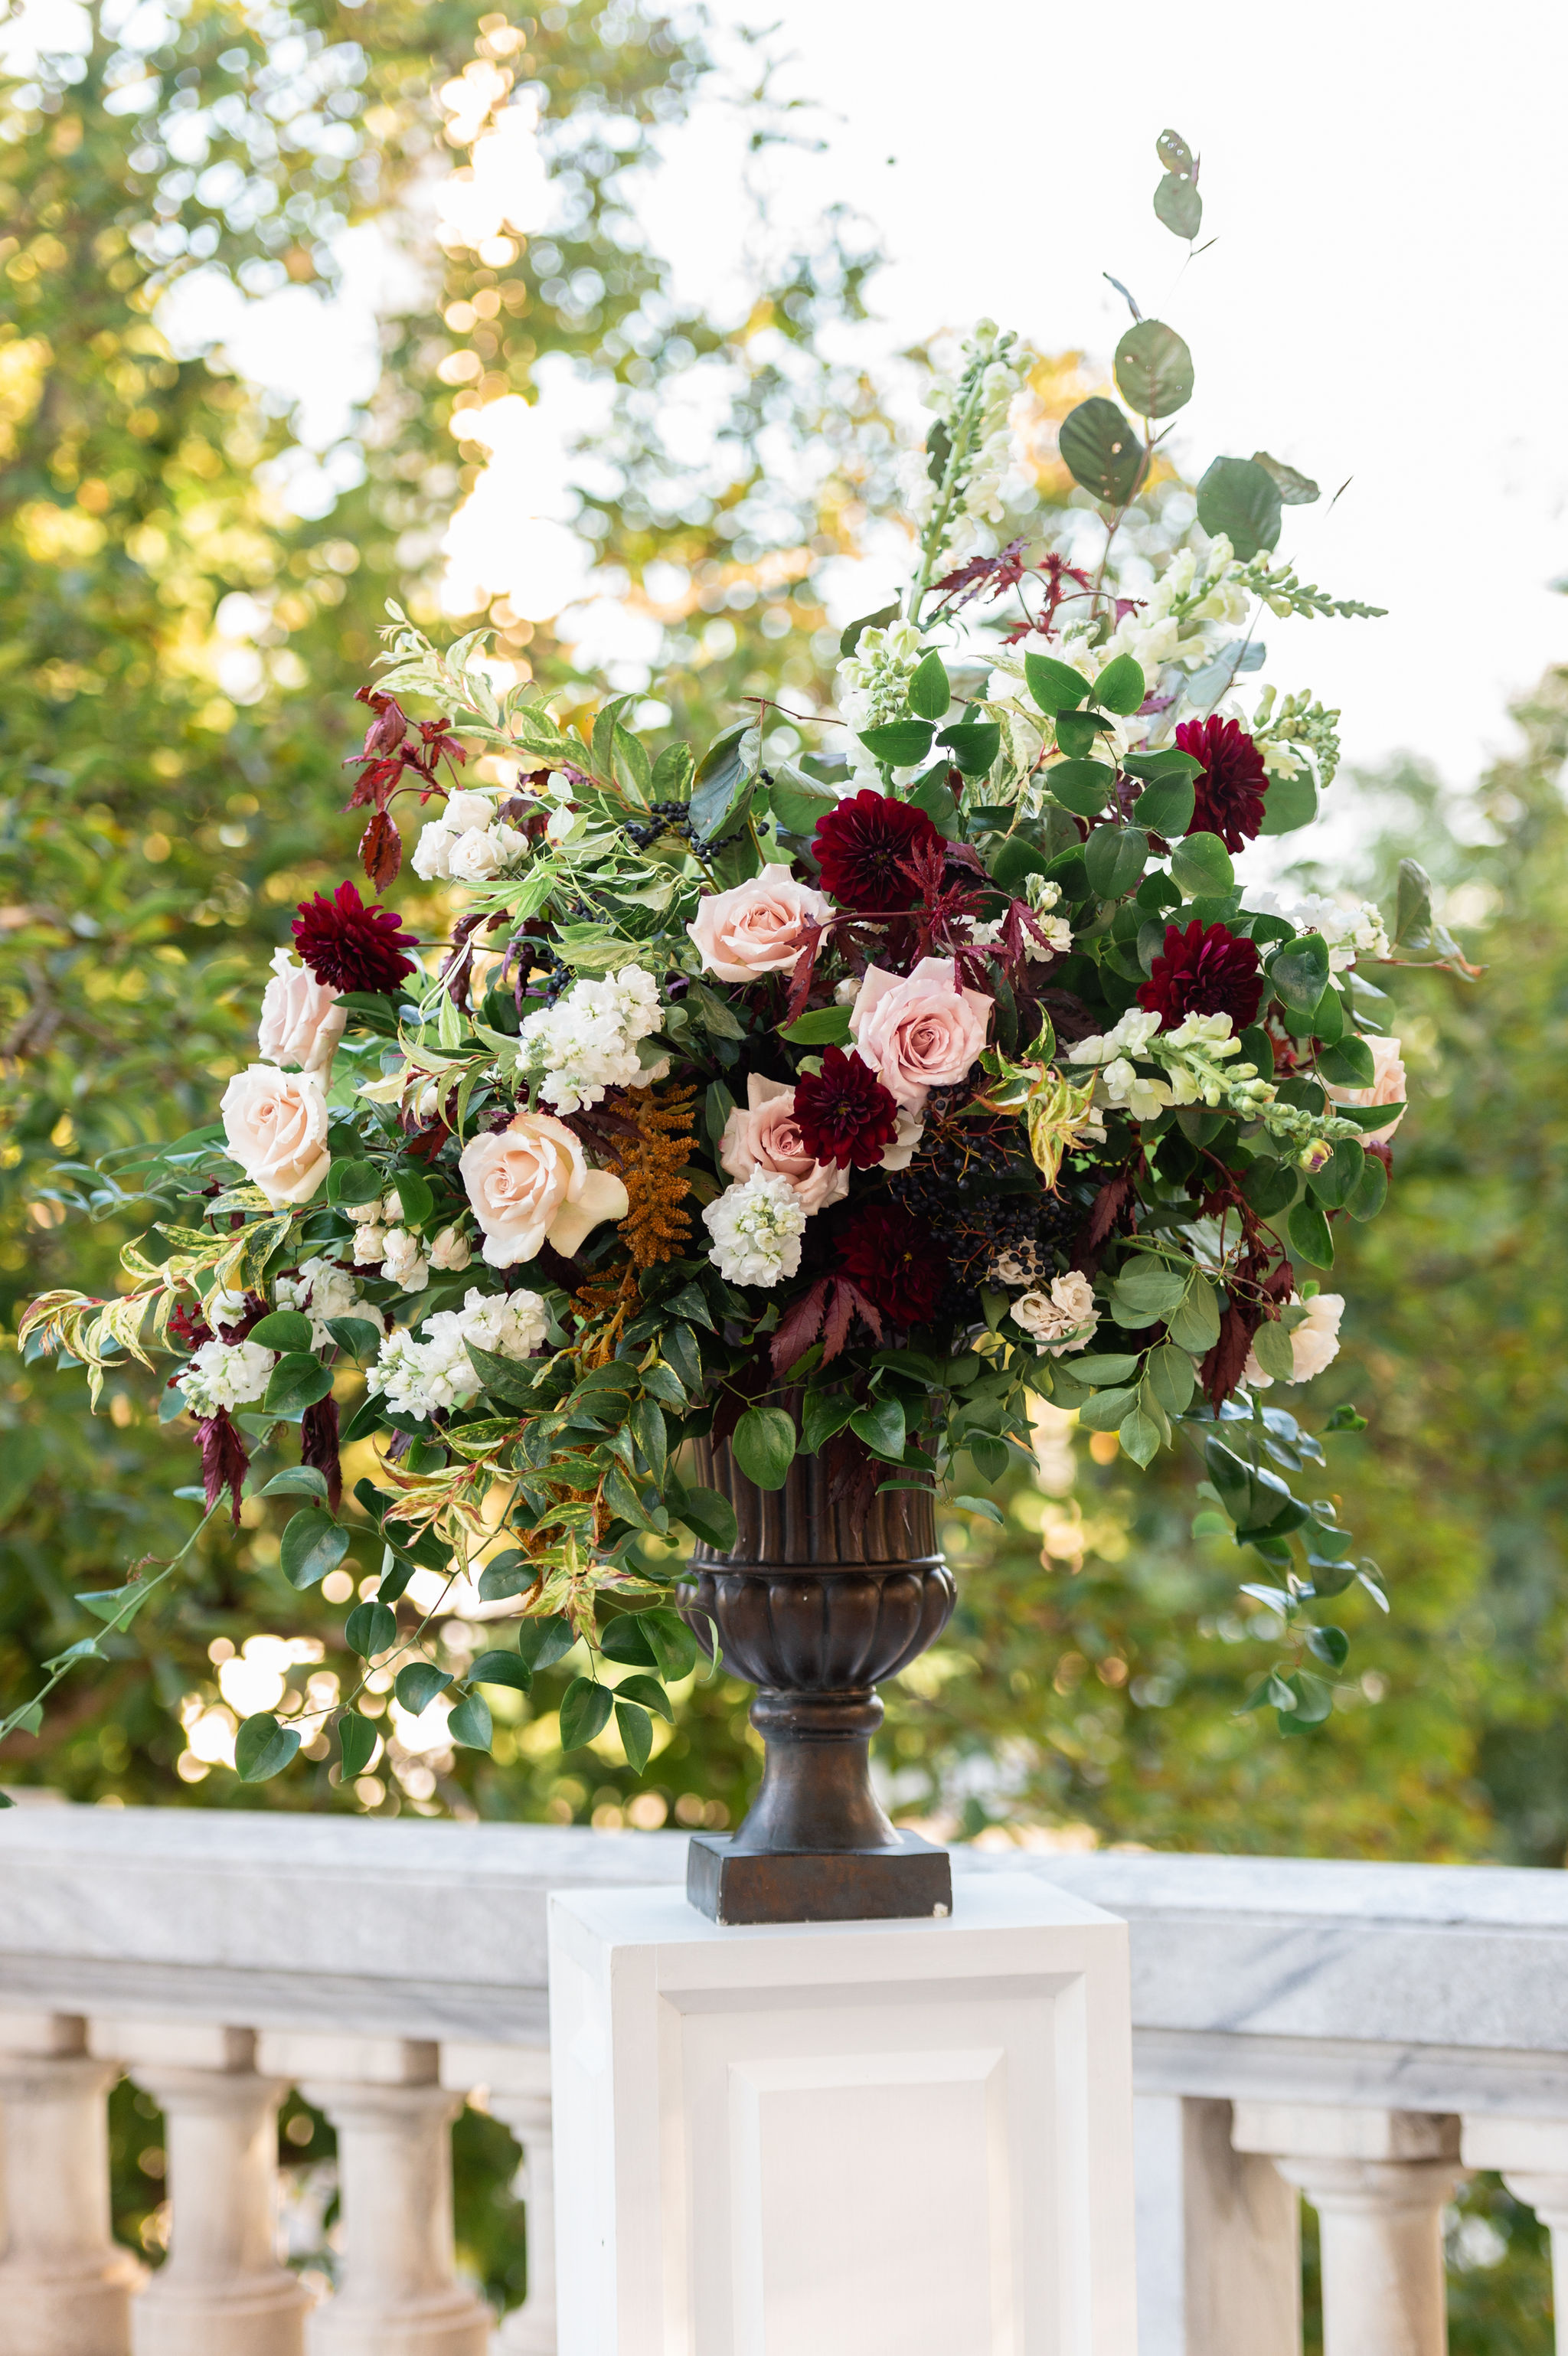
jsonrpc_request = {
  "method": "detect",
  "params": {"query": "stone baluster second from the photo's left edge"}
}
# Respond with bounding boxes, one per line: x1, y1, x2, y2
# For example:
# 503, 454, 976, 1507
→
92, 2021, 311, 2356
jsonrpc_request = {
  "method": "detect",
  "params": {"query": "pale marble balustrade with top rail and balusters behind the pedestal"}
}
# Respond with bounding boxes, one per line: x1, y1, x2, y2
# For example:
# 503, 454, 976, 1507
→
0, 1807, 1568, 2356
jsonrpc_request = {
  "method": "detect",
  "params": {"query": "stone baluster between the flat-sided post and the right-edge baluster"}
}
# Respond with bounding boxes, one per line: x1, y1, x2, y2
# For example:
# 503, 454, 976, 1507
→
1231, 2102, 1462, 2356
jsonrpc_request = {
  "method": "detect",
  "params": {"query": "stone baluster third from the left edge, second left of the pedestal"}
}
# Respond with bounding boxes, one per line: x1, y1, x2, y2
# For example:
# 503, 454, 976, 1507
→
259, 2031, 495, 2356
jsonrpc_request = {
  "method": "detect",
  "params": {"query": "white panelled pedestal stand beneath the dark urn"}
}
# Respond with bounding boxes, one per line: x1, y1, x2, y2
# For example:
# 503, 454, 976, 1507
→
551, 1873, 1135, 2356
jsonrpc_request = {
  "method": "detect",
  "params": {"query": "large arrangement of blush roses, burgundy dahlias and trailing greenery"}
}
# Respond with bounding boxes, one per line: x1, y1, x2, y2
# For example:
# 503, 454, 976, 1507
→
0, 134, 1462, 1779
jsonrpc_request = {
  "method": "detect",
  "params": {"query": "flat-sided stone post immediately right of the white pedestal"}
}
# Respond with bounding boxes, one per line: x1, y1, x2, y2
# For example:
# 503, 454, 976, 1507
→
1132, 2094, 1302, 2356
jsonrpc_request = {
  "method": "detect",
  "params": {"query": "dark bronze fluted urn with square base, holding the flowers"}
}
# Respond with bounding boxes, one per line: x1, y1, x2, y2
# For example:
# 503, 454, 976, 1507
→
683, 1442, 953, 1923
